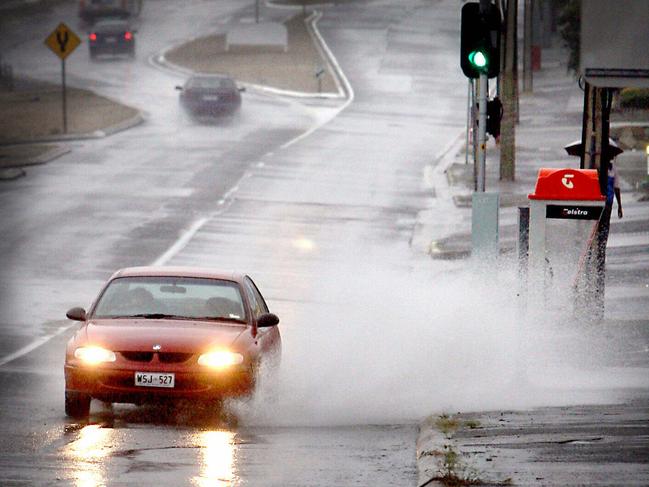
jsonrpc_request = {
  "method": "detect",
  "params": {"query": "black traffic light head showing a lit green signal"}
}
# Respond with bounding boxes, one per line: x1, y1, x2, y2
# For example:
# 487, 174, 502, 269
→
460, 2, 501, 78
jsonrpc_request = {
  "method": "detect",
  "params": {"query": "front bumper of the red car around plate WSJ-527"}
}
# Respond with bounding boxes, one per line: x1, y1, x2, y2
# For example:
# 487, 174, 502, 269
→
65, 365, 255, 404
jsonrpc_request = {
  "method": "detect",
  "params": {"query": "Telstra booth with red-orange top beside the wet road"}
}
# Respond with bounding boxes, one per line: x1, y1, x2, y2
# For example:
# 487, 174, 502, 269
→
527, 168, 606, 306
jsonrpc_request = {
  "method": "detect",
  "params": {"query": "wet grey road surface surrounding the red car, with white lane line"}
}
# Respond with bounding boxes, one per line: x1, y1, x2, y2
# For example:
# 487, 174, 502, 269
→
0, 1, 465, 486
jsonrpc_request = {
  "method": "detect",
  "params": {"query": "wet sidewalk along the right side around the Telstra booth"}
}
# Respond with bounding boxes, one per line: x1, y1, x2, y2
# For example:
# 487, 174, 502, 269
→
417, 43, 649, 486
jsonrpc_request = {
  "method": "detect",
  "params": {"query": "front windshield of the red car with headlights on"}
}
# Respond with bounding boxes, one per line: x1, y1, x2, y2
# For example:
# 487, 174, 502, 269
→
93, 277, 246, 322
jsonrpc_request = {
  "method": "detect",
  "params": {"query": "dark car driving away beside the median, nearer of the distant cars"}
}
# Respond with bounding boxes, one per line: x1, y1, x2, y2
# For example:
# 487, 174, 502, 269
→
176, 74, 245, 117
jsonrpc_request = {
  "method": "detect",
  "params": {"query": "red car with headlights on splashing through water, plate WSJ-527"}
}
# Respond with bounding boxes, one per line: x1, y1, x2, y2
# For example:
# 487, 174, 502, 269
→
65, 267, 281, 418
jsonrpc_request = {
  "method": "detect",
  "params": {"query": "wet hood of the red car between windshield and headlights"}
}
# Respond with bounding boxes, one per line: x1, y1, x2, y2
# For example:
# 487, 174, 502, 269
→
83, 319, 249, 352
